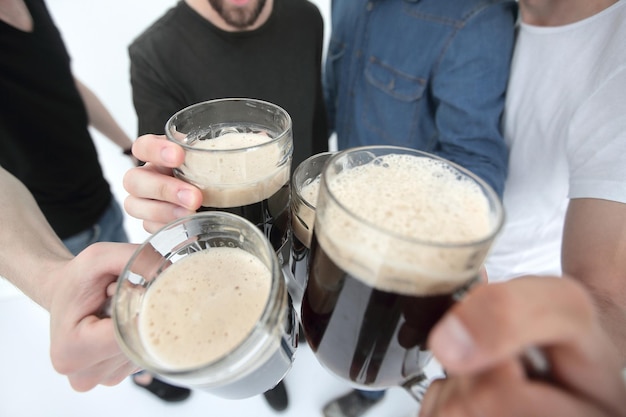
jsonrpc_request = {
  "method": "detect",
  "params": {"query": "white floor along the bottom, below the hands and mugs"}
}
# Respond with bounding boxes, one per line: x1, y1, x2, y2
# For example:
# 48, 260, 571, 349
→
0, 295, 418, 417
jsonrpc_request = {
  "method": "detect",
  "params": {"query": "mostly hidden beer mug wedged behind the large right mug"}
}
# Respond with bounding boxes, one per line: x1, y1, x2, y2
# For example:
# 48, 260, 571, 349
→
288, 152, 332, 305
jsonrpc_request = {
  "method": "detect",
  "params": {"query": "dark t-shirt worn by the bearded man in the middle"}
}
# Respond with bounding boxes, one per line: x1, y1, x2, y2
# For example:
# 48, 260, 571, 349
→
129, 0, 328, 168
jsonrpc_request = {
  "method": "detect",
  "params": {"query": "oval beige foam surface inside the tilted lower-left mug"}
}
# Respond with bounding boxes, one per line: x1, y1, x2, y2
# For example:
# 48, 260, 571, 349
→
138, 247, 272, 370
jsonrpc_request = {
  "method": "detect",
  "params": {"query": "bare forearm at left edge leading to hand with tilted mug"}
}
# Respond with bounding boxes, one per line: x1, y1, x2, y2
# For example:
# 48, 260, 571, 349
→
0, 167, 72, 309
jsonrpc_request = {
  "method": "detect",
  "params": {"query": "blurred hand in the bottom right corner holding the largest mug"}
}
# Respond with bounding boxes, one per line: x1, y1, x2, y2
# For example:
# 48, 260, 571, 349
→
420, 277, 626, 417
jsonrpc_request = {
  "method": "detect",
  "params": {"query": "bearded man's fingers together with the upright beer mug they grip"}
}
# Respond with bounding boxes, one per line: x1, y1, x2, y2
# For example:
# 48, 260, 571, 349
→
124, 98, 293, 256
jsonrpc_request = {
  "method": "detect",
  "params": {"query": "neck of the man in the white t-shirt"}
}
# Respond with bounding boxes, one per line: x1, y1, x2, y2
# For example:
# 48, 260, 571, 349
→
519, 0, 618, 26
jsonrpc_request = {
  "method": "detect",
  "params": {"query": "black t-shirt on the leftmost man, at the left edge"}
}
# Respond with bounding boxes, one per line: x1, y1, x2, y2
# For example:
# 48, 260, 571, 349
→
0, 0, 112, 238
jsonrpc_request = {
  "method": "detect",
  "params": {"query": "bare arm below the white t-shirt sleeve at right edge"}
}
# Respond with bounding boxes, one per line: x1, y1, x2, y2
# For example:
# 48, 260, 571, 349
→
562, 198, 626, 363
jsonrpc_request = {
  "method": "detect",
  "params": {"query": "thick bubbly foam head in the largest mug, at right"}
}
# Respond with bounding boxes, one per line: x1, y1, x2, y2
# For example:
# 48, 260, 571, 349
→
316, 154, 494, 295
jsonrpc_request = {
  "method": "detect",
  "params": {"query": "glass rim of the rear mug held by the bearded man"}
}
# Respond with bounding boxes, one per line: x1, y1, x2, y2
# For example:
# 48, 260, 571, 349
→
165, 97, 293, 154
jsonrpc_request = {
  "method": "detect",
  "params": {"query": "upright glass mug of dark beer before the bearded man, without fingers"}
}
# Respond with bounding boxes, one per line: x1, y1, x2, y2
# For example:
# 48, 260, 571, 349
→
165, 98, 293, 256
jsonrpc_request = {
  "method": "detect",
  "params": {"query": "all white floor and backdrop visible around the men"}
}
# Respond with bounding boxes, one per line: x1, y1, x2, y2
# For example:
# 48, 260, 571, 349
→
0, 0, 418, 417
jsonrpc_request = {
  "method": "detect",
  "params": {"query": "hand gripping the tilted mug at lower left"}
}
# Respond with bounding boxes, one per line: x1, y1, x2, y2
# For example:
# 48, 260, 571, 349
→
48, 243, 141, 391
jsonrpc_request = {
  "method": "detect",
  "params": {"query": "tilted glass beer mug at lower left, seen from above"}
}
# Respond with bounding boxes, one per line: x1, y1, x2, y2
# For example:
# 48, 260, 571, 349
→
111, 211, 298, 399
